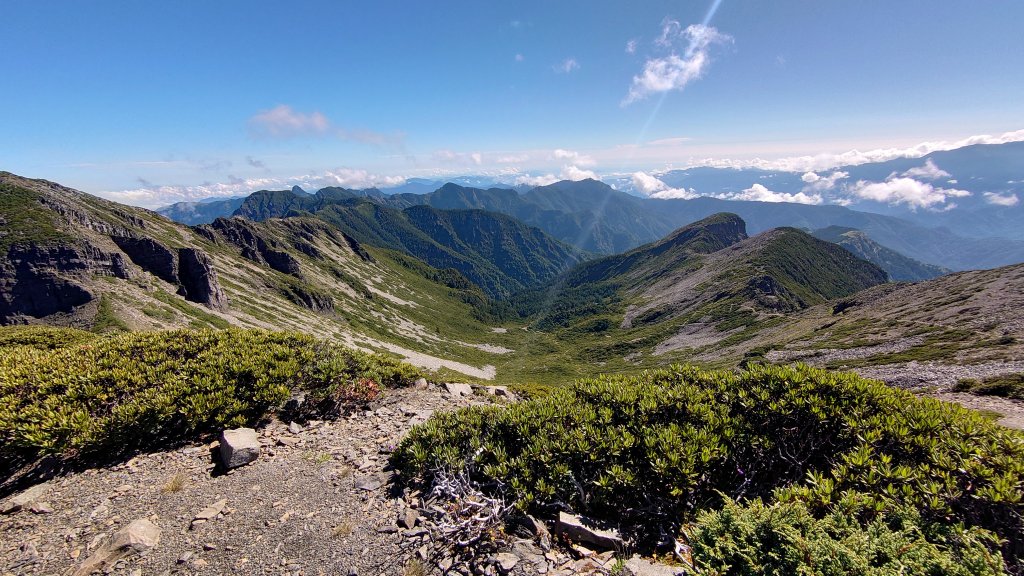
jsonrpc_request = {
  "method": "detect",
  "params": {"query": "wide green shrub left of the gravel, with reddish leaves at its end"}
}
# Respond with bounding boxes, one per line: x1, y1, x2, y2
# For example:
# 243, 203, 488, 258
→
0, 330, 418, 461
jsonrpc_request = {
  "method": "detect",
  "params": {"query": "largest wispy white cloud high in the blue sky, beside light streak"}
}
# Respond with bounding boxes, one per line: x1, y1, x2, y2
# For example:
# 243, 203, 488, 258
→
622, 20, 732, 106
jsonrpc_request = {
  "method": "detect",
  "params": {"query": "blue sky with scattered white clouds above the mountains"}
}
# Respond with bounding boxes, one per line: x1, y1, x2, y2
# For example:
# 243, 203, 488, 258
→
0, 0, 1024, 206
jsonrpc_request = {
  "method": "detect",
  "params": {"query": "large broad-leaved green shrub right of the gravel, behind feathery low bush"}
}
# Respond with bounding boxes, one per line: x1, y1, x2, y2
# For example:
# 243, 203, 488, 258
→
393, 366, 1024, 569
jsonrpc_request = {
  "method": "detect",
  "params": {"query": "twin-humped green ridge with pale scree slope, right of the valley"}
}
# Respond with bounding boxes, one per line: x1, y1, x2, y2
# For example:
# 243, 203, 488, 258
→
524, 213, 888, 340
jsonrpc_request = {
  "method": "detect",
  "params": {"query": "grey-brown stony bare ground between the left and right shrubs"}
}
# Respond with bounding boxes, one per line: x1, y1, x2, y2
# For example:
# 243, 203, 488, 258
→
0, 385, 655, 576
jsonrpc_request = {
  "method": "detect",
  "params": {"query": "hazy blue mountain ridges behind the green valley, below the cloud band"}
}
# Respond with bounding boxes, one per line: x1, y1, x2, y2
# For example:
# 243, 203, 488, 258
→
162, 166, 1024, 271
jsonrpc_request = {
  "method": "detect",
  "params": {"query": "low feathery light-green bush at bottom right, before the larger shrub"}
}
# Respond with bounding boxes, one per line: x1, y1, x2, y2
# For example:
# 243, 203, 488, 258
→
687, 500, 1002, 576
